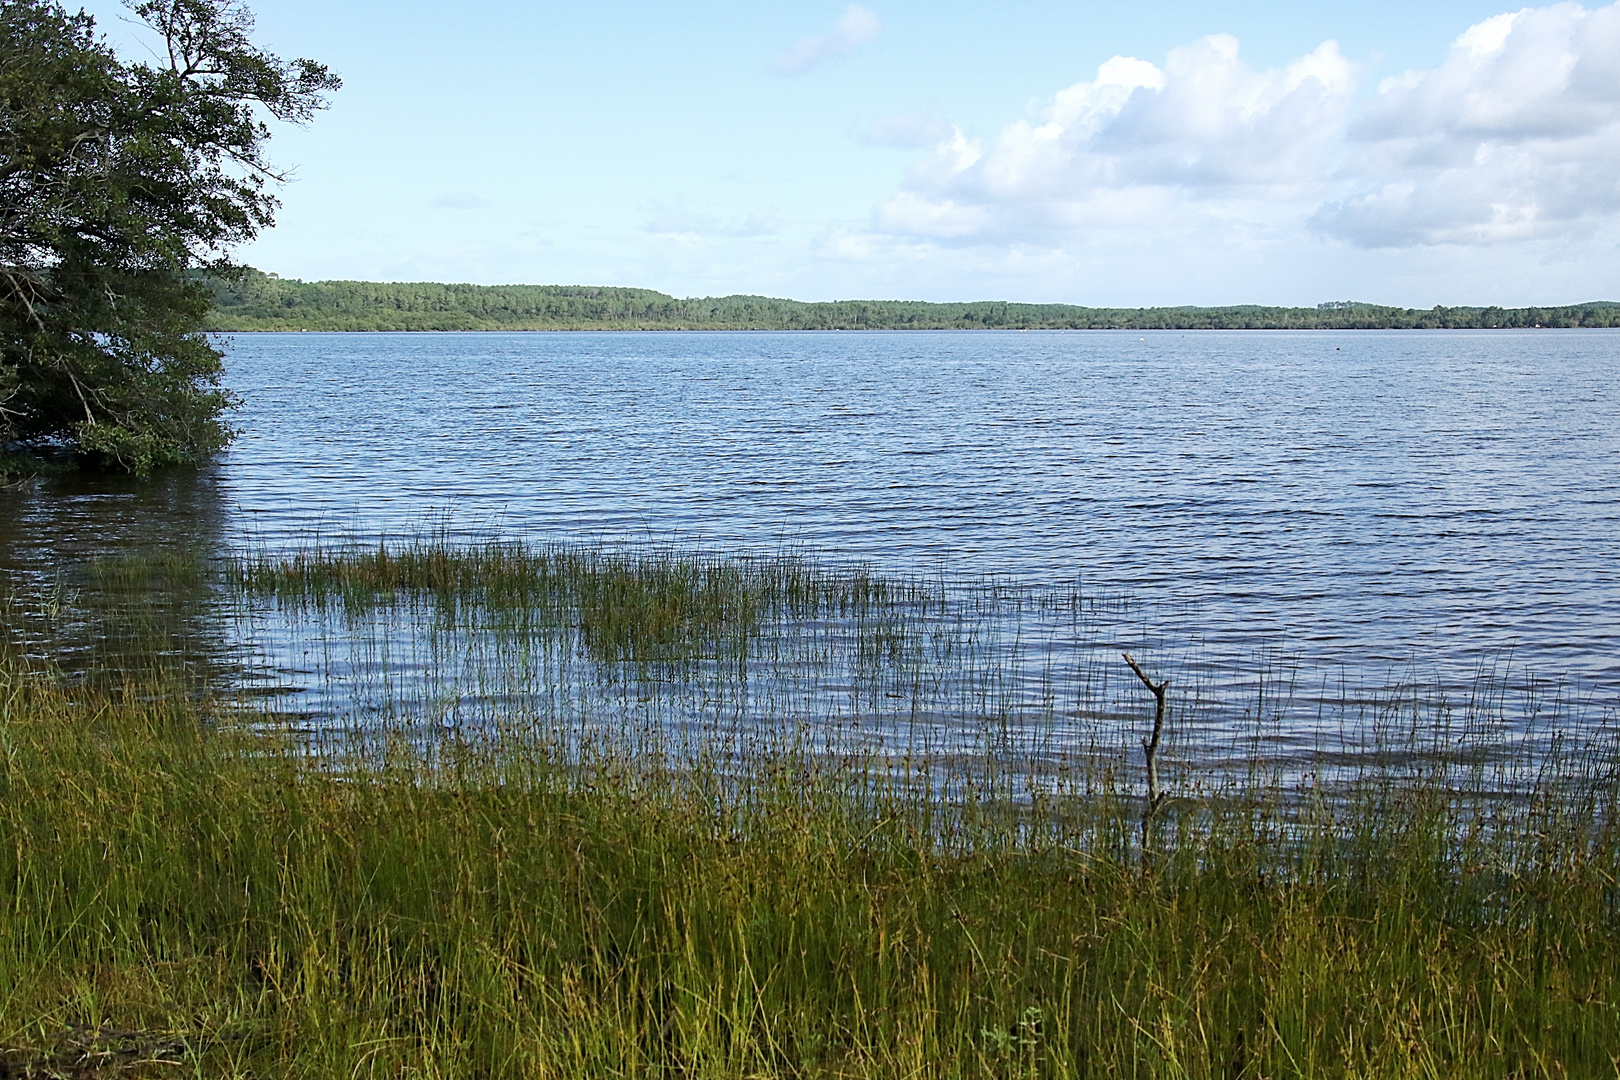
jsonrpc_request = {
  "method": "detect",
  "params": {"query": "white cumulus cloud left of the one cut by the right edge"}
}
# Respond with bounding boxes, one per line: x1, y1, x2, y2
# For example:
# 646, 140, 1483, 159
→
875, 34, 1356, 240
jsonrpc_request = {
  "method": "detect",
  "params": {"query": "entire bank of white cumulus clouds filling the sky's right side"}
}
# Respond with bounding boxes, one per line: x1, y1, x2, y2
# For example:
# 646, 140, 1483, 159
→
881, 3, 1620, 249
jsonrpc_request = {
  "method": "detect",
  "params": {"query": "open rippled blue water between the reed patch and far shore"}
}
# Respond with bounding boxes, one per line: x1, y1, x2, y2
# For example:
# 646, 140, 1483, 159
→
0, 330, 1620, 764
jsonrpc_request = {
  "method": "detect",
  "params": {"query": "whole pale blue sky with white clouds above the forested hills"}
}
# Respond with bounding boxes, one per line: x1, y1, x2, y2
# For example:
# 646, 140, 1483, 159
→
84, 0, 1620, 308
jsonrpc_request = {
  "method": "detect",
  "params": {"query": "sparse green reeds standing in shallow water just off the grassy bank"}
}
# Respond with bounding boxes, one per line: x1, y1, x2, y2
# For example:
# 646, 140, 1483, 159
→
220, 536, 1614, 798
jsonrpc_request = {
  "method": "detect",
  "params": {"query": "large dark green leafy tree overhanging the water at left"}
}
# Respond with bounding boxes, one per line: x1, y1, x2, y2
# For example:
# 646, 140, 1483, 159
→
0, 0, 340, 473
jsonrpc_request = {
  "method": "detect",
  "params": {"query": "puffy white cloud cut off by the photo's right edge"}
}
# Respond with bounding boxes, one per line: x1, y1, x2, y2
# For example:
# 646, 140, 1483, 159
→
1314, 3, 1620, 246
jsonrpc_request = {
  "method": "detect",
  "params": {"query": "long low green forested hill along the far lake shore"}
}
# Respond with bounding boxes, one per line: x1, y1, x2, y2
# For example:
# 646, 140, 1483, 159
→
207, 272, 1620, 332
